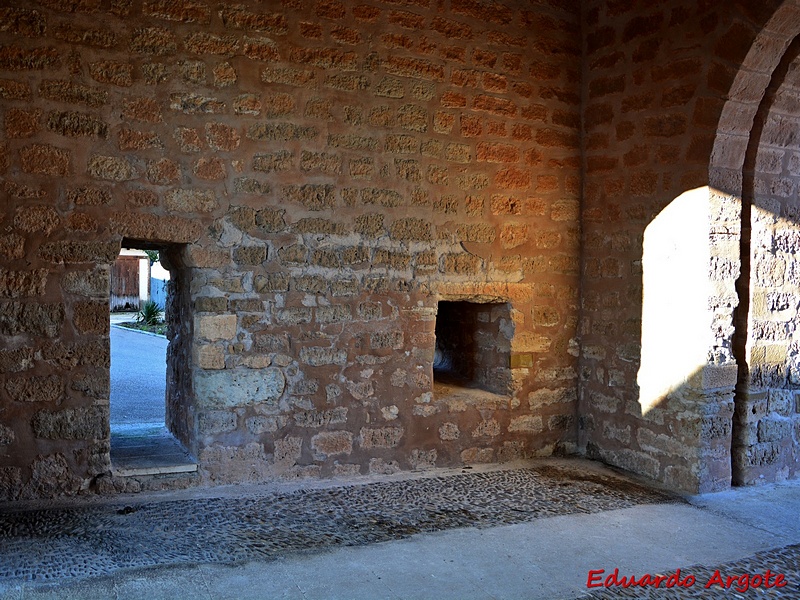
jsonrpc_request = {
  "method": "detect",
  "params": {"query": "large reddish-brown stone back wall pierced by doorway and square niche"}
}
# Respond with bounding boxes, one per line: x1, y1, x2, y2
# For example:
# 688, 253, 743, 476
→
0, 0, 580, 499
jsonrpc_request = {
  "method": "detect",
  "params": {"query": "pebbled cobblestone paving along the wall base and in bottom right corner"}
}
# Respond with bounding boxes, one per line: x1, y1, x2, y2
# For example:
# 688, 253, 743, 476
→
0, 463, 800, 600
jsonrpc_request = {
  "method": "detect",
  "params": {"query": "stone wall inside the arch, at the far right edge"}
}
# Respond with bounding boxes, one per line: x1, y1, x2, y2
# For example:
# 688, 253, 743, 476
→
733, 39, 800, 485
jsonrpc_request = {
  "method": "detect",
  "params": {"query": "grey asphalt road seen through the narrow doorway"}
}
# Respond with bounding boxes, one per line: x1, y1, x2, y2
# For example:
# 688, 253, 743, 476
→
111, 327, 167, 427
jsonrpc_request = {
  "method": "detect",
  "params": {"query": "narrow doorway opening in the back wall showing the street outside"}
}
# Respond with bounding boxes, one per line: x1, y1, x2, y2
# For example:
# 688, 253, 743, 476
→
110, 239, 197, 477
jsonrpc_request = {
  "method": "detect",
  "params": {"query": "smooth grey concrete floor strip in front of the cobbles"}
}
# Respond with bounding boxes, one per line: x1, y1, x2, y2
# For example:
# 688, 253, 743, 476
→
0, 461, 800, 600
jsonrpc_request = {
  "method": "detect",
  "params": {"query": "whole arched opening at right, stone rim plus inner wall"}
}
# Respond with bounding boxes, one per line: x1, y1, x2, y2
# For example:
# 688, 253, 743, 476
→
709, 2, 800, 485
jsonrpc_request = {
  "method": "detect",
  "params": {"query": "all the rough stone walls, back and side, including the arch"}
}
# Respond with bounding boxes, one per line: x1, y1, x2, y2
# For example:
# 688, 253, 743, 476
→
0, 0, 800, 499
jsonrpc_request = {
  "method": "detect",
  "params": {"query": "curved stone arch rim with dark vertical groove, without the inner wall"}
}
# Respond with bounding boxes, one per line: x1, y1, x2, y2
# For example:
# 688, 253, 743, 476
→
709, 0, 800, 485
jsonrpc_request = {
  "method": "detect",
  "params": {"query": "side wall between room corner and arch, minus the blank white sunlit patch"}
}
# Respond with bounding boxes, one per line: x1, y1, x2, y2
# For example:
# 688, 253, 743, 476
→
580, 2, 779, 491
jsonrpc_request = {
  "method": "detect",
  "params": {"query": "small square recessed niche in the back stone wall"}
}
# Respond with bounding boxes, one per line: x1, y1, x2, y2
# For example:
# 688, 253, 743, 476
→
433, 301, 513, 394
